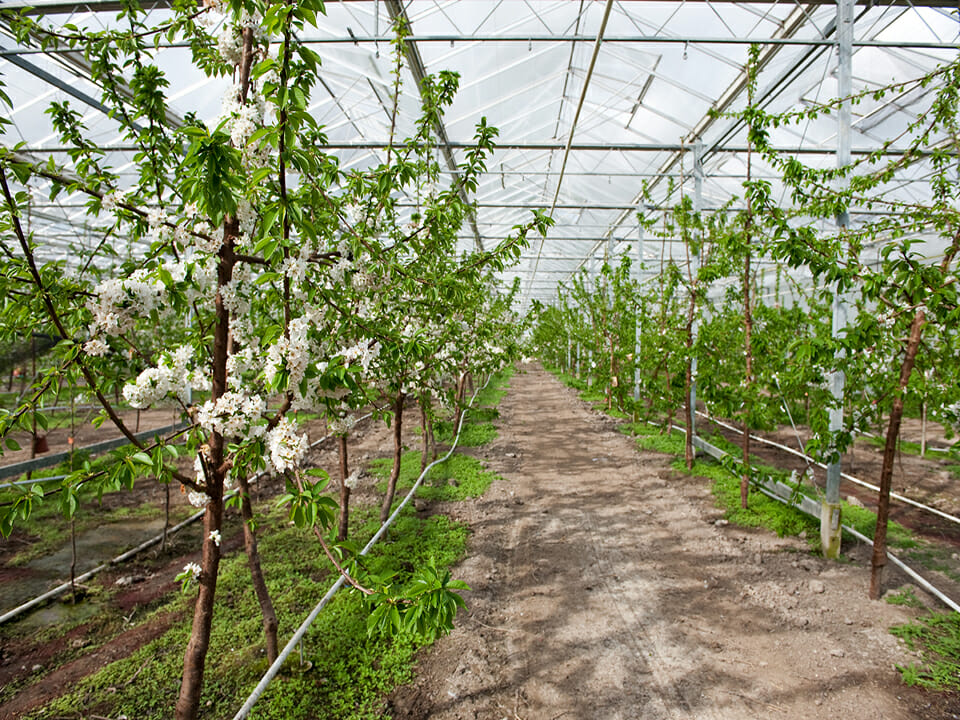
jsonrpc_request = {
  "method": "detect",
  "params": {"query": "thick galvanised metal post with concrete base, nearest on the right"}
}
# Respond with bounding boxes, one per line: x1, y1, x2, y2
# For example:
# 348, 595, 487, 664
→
820, 0, 854, 559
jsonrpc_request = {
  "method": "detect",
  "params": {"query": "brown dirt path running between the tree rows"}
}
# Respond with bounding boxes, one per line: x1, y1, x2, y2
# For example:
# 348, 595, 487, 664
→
390, 367, 960, 720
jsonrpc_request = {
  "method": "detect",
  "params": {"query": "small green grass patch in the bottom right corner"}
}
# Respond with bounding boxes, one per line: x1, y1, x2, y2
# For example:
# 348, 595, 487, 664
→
890, 613, 960, 691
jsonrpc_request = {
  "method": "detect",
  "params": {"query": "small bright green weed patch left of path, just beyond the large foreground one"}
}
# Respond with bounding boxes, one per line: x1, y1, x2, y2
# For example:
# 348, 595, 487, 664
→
370, 452, 499, 502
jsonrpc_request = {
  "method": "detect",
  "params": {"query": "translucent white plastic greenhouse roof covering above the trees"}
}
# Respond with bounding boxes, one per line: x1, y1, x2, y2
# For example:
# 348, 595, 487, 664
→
0, 0, 960, 304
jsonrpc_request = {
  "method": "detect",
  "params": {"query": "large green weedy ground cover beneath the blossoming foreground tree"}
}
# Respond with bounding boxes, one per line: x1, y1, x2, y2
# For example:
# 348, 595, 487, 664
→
30, 500, 468, 720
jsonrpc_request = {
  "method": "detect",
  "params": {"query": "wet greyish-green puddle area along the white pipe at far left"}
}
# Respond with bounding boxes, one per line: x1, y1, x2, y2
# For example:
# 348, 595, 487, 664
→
0, 518, 163, 624
